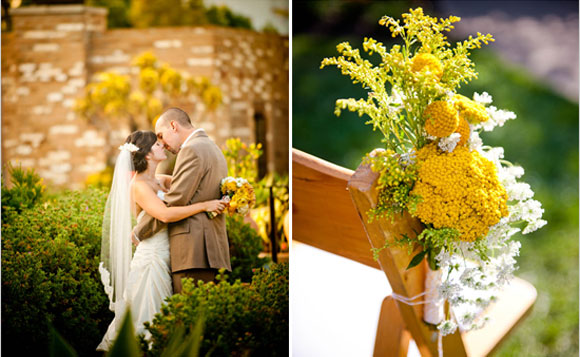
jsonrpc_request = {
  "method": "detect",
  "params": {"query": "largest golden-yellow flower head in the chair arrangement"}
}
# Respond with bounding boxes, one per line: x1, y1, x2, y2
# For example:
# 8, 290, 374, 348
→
411, 143, 508, 241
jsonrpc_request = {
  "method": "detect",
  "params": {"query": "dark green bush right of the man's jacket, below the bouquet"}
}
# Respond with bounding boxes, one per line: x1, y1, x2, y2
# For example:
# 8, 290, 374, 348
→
226, 215, 269, 282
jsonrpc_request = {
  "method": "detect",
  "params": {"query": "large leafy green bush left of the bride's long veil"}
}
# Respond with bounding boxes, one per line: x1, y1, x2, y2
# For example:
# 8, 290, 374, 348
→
2, 189, 112, 355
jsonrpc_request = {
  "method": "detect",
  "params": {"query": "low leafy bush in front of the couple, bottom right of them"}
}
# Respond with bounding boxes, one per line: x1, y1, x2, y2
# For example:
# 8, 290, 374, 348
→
147, 263, 289, 356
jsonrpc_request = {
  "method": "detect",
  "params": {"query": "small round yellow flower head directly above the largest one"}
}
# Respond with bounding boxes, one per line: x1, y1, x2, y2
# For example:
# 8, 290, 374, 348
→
423, 100, 459, 138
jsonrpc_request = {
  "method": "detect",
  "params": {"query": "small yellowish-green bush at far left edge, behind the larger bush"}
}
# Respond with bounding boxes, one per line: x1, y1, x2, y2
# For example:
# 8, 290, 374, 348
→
2, 164, 45, 217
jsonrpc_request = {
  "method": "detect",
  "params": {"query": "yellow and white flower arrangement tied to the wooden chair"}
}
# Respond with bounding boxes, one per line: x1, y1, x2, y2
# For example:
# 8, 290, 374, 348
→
321, 8, 546, 336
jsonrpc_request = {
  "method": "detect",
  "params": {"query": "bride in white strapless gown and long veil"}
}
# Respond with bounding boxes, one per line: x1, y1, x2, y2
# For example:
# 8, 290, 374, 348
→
97, 131, 225, 351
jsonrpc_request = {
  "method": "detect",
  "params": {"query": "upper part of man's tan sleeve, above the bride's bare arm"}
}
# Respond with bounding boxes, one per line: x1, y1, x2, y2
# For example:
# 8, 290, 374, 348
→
165, 146, 205, 207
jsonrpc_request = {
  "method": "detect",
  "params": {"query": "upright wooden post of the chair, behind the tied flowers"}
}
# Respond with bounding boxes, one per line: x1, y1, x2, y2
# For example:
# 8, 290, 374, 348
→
348, 165, 466, 357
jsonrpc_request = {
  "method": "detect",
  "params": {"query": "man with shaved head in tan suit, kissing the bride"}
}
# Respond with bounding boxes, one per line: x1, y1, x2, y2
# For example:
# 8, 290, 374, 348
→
133, 108, 231, 294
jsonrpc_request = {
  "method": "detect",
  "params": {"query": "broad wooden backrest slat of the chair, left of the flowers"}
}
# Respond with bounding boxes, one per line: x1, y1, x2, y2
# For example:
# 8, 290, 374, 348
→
292, 149, 380, 269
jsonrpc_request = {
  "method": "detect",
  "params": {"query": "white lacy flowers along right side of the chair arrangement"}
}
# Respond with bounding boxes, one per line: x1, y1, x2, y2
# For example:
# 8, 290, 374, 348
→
435, 92, 547, 335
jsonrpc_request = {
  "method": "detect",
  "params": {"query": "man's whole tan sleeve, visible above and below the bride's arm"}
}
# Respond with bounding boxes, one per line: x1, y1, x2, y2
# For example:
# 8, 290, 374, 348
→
133, 146, 203, 240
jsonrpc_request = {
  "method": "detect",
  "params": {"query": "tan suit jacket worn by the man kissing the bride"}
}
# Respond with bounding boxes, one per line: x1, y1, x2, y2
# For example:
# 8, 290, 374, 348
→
134, 130, 231, 272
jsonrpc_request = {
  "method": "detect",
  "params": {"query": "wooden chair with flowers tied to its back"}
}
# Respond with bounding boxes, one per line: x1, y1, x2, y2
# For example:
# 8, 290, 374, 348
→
292, 149, 537, 356
